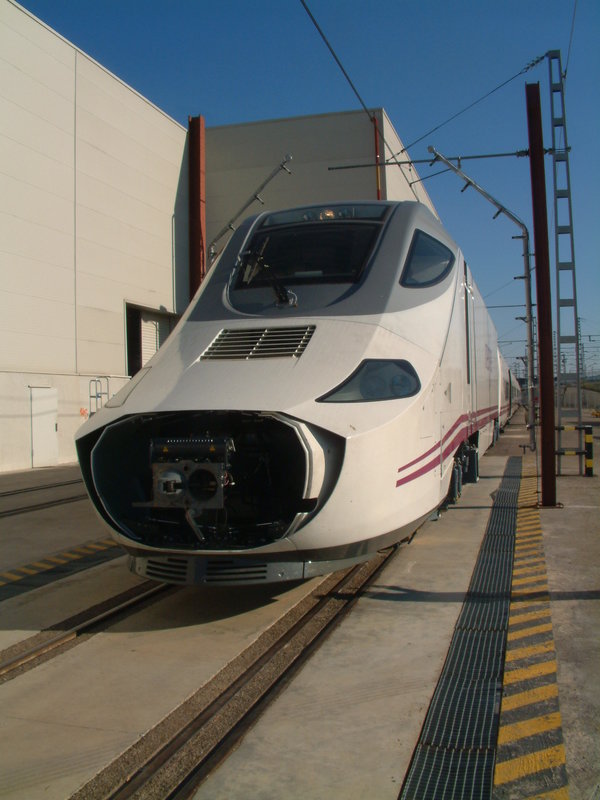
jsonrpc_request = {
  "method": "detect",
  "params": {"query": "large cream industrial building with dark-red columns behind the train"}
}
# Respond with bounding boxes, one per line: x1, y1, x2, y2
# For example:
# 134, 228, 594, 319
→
0, 0, 433, 471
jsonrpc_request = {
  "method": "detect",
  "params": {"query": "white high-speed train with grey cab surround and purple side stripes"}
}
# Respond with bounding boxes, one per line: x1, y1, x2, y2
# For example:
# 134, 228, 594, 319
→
77, 202, 519, 584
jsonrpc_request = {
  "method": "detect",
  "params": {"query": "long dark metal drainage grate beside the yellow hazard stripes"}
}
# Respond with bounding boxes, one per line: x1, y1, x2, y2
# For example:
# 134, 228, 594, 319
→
399, 458, 521, 800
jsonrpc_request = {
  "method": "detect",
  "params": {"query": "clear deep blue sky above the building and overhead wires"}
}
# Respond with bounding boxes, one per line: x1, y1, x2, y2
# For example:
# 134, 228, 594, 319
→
22, 0, 600, 373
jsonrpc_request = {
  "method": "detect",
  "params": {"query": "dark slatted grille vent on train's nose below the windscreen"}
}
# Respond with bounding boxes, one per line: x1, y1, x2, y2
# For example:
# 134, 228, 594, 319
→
200, 325, 315, 360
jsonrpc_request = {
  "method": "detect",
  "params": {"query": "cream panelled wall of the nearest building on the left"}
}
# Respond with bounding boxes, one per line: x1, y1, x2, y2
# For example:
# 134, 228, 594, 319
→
0, 0, 188, 470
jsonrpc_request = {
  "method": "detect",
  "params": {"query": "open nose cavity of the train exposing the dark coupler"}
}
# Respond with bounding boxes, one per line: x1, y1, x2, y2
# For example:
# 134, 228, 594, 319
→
84, 412, 344, 551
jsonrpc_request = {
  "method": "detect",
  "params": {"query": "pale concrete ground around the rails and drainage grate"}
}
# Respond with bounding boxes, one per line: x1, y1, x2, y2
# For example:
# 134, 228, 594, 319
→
0, 418, 600, 800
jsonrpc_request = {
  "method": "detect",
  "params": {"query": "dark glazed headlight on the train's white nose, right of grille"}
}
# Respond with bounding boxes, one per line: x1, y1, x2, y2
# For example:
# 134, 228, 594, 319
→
317, 359, 421, 403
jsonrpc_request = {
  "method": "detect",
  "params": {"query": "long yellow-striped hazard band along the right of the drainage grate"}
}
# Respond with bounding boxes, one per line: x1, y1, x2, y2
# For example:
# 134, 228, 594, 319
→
494, 459, 569, 800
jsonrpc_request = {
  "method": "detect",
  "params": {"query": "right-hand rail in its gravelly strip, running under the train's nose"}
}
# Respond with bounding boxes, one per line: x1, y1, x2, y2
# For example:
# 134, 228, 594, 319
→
70, 548, 396, 800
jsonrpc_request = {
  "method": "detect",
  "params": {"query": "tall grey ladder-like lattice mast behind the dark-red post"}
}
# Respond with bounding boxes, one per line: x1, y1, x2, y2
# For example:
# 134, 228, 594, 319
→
547, 50, 584, 475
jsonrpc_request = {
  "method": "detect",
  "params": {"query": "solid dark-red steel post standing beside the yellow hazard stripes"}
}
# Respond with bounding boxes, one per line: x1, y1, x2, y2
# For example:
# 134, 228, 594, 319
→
525, 83, 556, 506
